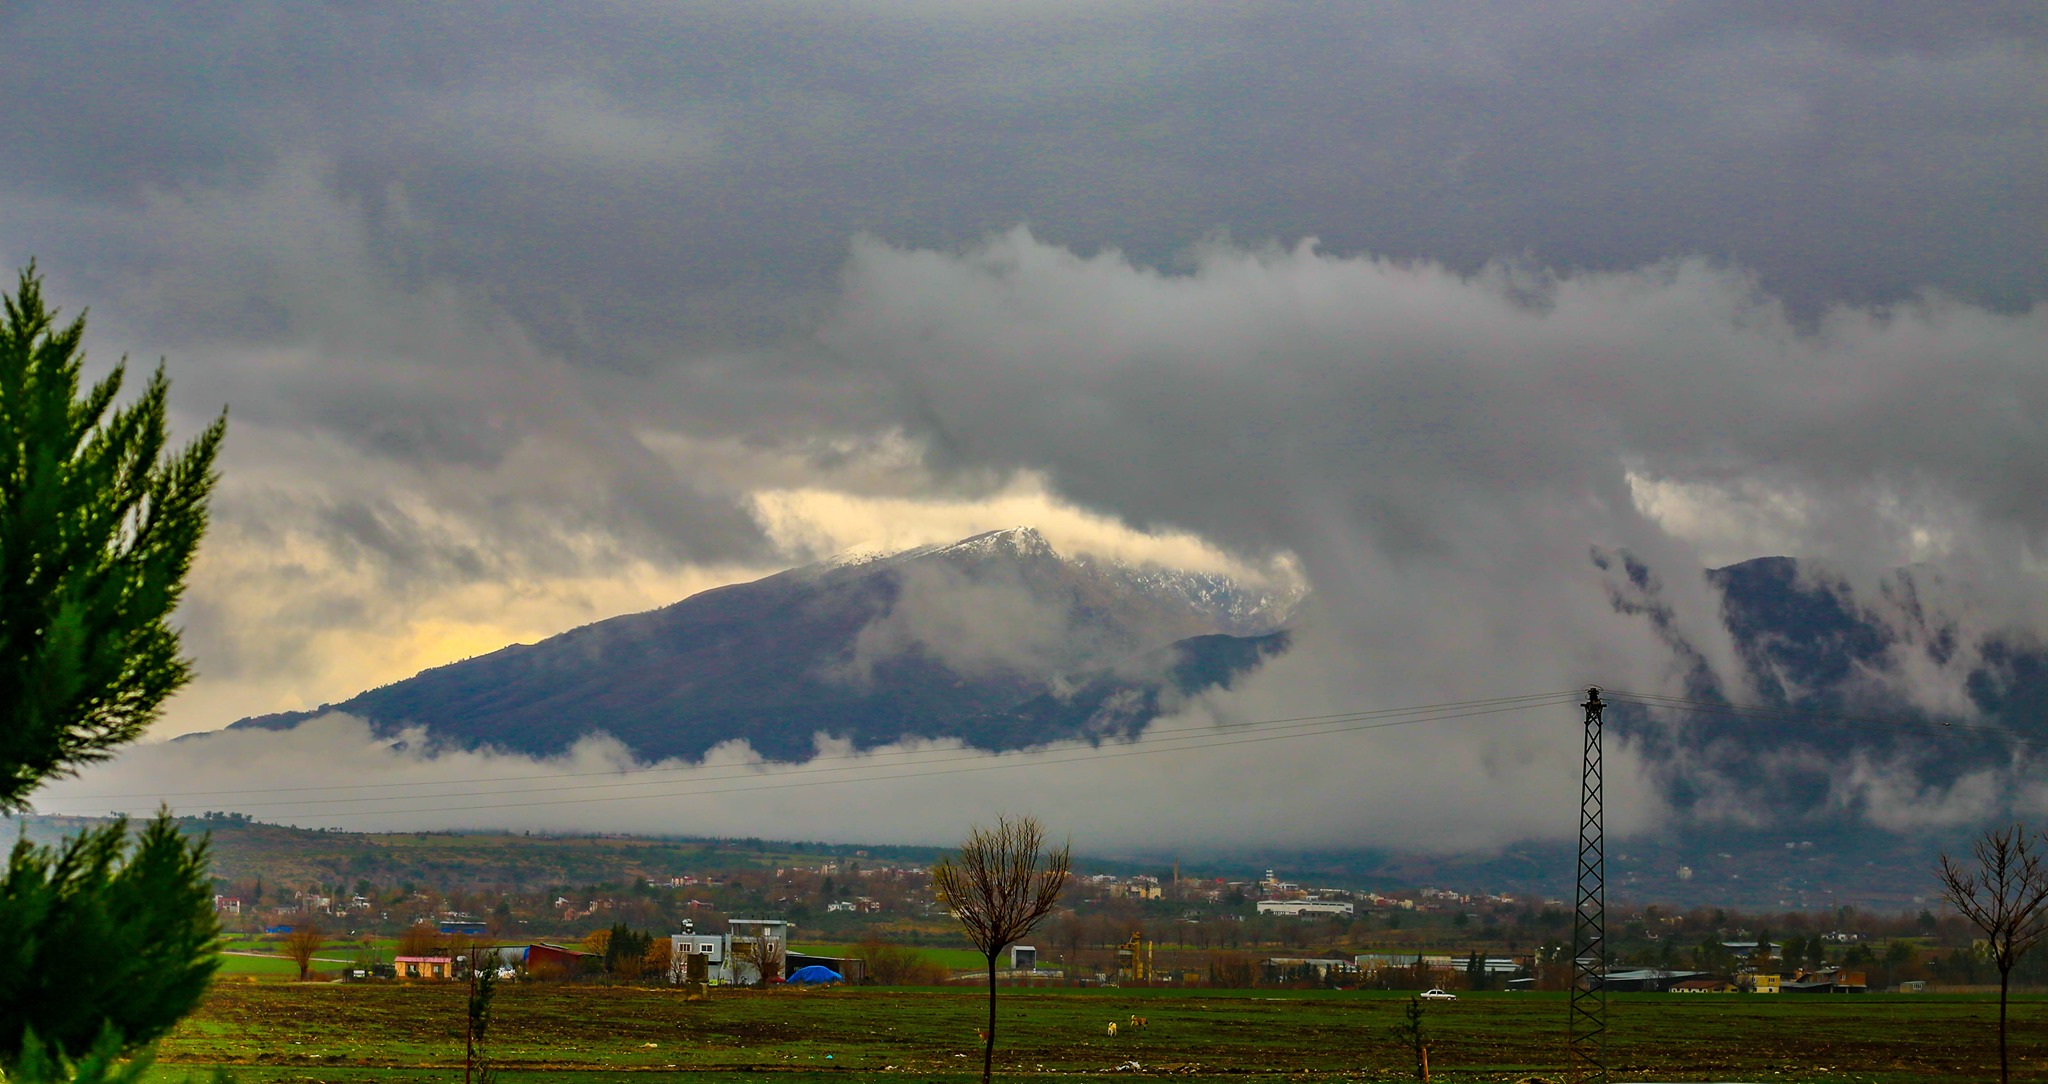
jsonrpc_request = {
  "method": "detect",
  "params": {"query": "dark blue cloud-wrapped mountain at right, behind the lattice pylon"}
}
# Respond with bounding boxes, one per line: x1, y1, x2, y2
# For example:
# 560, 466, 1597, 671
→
1595, 557, 2048, 840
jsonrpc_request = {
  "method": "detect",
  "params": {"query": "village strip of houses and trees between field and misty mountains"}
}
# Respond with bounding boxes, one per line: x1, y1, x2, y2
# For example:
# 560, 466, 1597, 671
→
215, 850, 1989, 994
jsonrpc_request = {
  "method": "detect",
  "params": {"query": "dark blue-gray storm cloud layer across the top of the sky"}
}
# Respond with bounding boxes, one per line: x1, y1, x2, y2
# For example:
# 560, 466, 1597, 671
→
0, 4, 2048, 365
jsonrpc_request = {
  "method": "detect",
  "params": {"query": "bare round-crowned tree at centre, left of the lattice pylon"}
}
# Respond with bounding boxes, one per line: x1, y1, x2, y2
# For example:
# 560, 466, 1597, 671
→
932, 818, 1073, 1084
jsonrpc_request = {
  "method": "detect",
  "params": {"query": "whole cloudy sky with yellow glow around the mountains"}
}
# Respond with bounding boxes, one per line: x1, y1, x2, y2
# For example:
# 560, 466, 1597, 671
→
0, 0, 2048, 846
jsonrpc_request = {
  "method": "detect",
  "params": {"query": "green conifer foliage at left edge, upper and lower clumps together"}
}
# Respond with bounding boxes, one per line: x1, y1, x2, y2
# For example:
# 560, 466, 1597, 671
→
0, 264, 225, 1078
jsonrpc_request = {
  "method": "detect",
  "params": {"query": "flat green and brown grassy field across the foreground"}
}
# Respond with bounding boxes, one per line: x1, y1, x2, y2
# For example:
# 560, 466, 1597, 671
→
140, 982, 2048, 1084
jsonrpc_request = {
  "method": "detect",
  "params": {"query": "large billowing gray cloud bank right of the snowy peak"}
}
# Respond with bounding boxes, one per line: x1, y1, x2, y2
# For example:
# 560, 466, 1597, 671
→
825, 232, 2048, 816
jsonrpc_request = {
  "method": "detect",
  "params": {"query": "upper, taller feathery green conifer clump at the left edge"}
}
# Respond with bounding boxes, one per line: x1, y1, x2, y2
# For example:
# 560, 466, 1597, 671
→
0, 264, 225, 811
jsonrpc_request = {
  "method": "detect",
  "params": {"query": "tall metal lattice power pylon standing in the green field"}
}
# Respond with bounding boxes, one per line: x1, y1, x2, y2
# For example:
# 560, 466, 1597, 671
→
1565, 689, 1608, 1082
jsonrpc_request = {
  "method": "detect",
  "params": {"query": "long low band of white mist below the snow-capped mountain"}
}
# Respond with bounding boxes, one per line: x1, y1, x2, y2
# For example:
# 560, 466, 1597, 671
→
35, 705, 1661, 852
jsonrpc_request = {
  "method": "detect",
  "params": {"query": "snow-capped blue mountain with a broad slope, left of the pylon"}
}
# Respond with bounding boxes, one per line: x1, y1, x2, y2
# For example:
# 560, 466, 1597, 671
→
231, 527, 1298, 760
